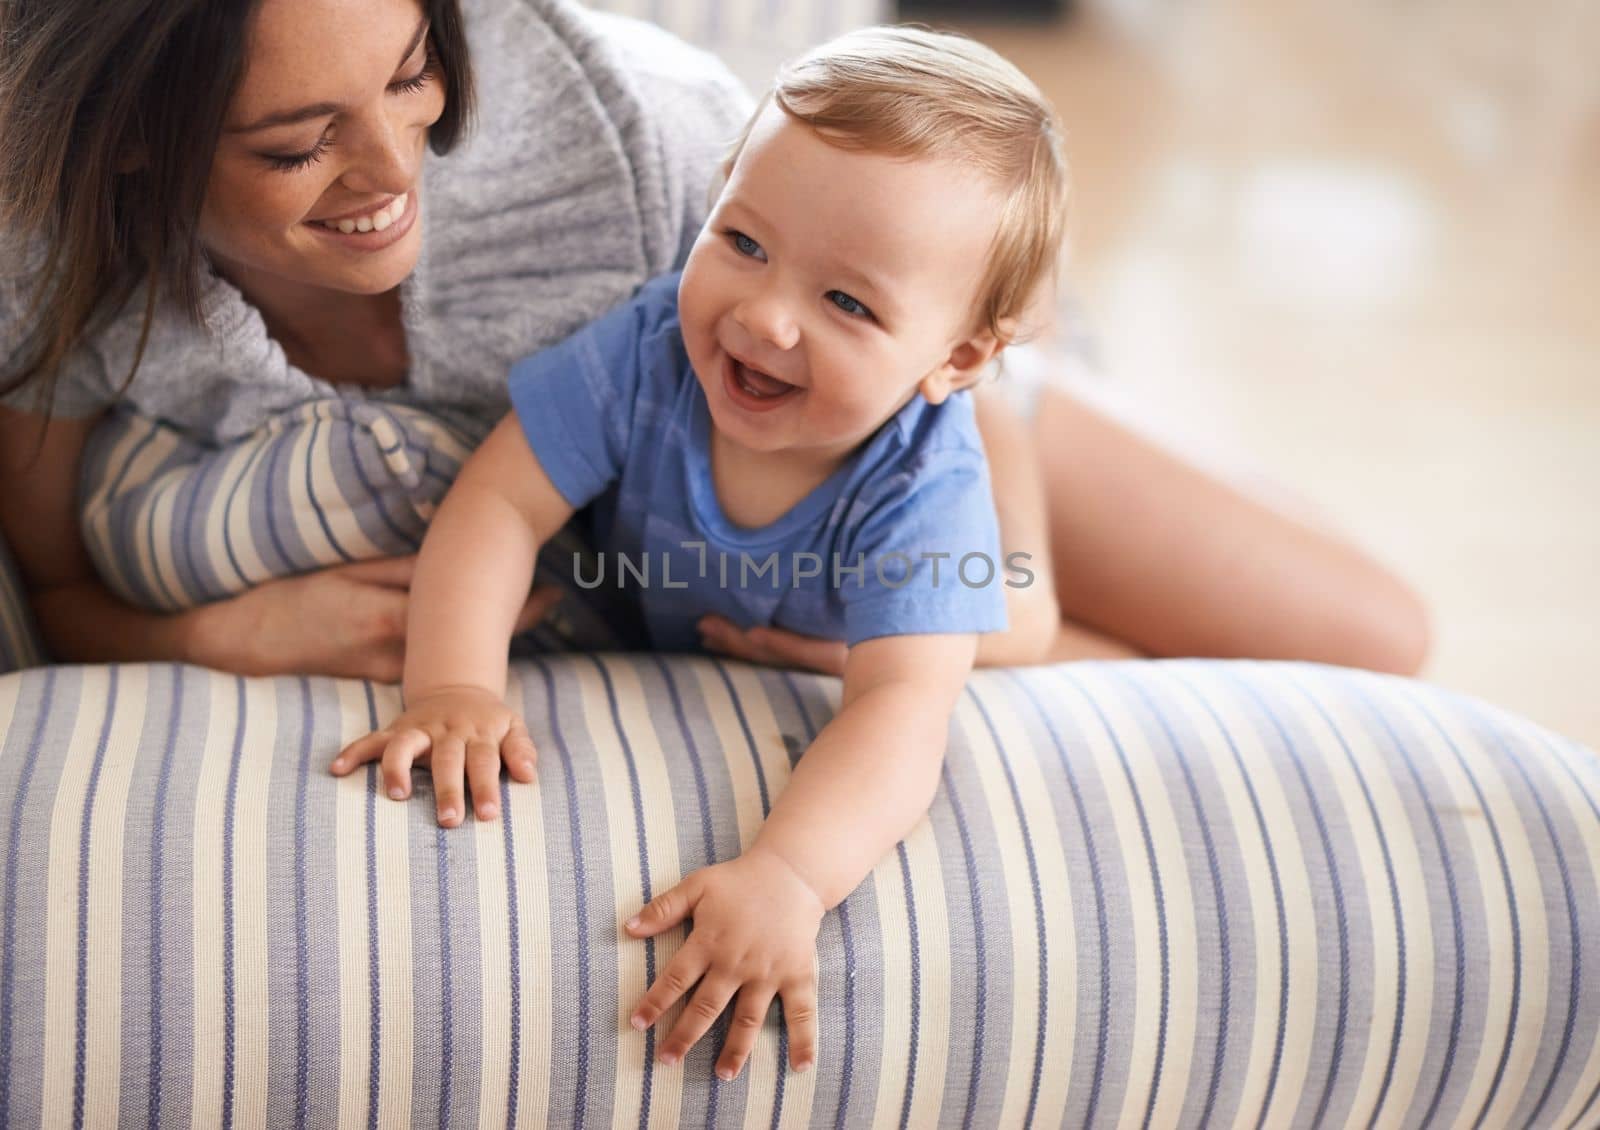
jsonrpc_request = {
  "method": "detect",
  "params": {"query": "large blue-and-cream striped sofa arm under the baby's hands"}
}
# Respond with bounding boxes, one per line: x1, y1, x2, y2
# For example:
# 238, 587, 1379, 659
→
0, 656, 1600, 1127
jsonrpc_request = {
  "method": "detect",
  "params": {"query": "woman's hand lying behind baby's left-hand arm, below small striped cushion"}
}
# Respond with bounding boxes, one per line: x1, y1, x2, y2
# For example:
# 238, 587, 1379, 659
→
187, 557, 560, 683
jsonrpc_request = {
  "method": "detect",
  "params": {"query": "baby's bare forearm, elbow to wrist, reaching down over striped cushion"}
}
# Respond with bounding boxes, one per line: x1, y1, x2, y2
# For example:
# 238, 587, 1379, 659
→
750, 682, 949, 909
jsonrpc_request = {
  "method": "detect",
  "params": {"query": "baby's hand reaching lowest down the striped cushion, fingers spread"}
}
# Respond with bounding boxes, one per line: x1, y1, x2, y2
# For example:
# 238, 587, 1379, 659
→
627, 848, 826, 1079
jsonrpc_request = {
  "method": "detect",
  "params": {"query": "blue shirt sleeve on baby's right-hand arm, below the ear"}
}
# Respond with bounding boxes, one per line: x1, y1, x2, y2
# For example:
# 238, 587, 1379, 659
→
838, 448, 1006, 647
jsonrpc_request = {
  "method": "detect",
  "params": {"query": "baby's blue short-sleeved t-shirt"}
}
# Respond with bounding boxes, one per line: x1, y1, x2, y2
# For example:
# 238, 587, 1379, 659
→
510, 274, 1008, 651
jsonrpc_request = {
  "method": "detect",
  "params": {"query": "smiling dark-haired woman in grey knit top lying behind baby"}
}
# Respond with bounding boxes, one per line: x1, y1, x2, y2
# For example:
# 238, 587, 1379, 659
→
0, 0, 1426, 680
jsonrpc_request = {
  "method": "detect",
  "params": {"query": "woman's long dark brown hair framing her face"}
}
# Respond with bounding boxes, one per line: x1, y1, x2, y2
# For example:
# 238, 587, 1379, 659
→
0, 0, 474, 413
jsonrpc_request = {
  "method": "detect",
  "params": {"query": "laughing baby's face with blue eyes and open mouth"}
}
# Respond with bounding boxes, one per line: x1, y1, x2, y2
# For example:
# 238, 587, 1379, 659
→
678, 106, 1000, 461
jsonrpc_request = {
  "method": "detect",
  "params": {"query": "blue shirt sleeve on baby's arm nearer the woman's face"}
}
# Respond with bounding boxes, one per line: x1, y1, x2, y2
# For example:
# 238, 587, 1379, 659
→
509, 275, 678, 507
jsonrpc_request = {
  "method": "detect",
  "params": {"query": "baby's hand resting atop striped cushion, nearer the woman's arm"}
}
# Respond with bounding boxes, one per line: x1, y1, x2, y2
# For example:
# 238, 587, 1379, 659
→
330, 687, 538, 827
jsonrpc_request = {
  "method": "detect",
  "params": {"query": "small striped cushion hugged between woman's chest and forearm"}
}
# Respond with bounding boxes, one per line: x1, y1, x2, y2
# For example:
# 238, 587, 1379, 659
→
82, 400, 472, 611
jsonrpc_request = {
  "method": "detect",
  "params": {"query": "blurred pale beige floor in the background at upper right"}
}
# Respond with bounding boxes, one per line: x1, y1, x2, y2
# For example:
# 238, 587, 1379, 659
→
904, 0, 1600, 747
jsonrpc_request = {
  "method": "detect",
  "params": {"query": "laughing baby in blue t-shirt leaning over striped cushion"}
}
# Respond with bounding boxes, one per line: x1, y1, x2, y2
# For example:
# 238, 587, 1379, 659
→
333, 29, 1066, 1079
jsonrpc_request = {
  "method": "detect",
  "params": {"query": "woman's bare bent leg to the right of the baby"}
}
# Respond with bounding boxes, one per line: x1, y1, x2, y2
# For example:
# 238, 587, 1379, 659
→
1030, 391, 1427, 674
